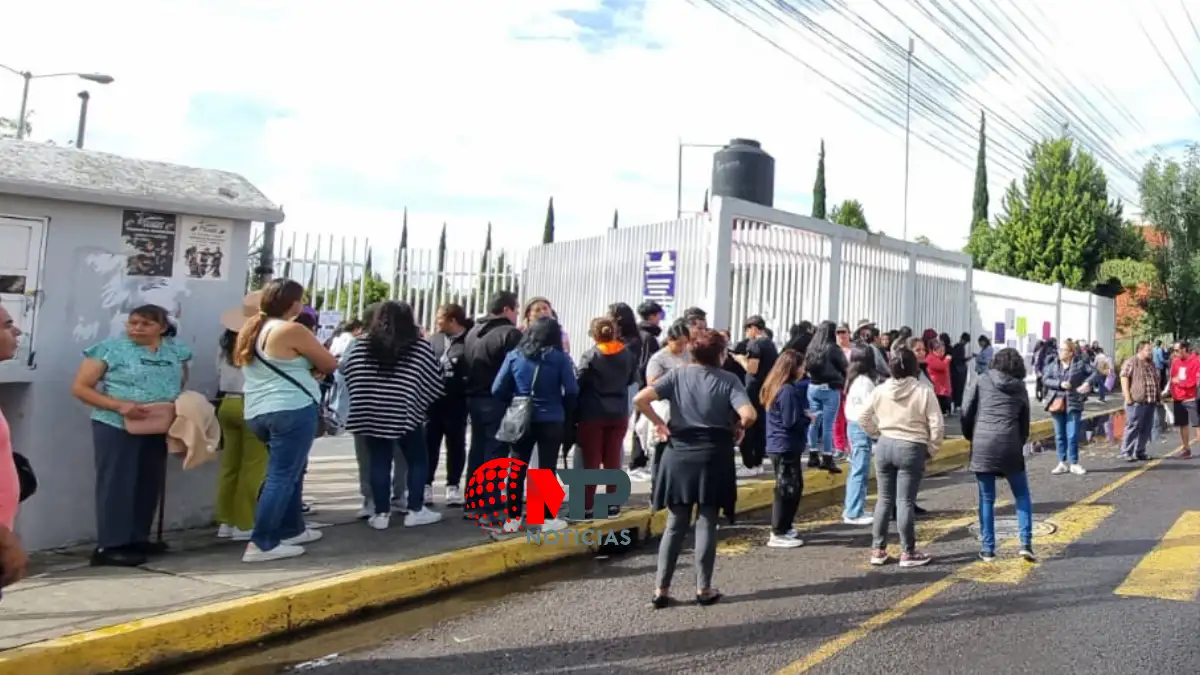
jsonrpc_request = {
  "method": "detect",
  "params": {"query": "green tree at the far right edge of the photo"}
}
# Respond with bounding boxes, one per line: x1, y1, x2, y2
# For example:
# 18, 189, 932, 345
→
1139, 145, 1200, 339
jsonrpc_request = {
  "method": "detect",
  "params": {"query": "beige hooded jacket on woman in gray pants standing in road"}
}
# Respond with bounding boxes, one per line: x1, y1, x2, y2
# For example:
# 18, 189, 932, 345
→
858, 377, 946, 453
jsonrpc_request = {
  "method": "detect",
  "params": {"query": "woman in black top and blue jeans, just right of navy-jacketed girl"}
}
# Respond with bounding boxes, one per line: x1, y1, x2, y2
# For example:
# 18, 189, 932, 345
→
804, 321, 850, 473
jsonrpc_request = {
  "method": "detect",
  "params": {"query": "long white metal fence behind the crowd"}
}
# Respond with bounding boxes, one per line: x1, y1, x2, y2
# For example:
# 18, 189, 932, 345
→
255, 198, 1116, 356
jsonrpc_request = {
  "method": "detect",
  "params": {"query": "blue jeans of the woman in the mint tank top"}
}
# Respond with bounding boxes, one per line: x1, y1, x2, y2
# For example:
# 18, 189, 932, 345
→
246, 406, 317, 551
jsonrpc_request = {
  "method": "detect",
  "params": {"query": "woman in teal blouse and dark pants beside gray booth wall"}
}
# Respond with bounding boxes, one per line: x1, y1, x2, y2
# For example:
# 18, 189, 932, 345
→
71, 305, 192, 567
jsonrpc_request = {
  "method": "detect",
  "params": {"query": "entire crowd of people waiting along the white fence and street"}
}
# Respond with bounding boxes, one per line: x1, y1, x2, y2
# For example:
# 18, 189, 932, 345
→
0, 280, 1180, 595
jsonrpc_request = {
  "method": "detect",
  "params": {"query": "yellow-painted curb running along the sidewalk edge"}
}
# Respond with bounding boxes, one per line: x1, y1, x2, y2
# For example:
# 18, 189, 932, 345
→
0, 403, 1112, 675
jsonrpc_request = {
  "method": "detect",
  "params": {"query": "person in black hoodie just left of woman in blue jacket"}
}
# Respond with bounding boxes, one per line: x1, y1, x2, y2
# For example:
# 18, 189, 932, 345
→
463, 291, 521, 516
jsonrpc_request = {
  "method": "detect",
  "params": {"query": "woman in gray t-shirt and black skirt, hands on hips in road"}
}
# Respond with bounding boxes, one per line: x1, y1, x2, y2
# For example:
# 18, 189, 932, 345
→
634, 330, 755, 609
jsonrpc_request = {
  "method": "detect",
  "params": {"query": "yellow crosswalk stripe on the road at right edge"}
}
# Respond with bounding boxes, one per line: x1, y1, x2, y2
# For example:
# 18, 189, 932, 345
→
1114, 510, 1200, 602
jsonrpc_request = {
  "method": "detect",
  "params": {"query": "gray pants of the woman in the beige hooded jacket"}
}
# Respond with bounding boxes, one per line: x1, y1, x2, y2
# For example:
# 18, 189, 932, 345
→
871, 436, 929, 554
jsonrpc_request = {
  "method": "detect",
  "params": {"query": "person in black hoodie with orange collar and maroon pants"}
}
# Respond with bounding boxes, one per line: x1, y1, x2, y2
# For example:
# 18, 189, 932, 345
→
577, 317, 637, 518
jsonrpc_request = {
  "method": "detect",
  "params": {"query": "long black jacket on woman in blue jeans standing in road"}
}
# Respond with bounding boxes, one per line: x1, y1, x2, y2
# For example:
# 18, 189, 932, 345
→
962, 370, 1030, 476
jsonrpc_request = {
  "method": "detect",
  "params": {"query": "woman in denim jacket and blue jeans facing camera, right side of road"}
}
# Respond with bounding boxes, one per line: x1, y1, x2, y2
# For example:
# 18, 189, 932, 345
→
1042, 340, 1096, 476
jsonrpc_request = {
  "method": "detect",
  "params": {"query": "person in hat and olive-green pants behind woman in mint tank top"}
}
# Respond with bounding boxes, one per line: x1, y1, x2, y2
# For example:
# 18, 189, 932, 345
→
216, 291, 274, 542
